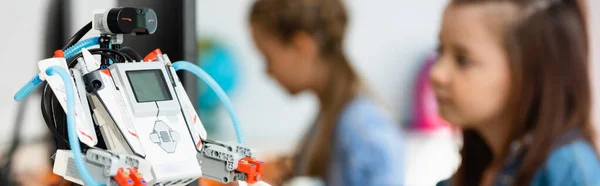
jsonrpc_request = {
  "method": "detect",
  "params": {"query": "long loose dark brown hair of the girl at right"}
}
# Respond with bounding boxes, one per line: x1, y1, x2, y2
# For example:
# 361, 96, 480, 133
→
452, 0, 595, 186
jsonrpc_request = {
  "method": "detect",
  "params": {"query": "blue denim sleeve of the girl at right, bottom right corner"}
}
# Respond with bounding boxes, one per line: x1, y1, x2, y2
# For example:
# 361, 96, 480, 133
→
531, 140, 600, 186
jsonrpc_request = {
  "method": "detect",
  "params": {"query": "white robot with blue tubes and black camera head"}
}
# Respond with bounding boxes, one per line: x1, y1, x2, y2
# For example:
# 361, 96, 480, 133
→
15, 7, 268, 186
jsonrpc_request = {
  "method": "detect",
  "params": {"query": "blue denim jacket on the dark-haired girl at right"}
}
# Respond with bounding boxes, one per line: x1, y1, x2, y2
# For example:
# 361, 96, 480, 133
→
438, 130, 600, 186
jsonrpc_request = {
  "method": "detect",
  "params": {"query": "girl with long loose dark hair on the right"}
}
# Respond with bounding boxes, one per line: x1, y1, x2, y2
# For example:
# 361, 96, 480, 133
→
430, 0, 600, 186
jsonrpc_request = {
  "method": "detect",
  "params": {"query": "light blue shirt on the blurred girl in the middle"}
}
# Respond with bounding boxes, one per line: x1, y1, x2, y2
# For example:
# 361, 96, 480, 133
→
326, 97, 405, 186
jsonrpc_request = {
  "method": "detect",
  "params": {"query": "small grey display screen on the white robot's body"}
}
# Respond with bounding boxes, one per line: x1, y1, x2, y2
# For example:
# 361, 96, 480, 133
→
126, 69, 172, 103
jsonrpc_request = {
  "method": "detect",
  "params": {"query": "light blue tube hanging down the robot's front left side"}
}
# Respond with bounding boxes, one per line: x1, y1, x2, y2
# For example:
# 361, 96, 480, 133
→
46, 66, 104, 186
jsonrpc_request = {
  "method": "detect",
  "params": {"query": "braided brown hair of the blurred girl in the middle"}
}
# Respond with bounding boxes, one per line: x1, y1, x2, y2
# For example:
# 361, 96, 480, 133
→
250, 0, 359, 181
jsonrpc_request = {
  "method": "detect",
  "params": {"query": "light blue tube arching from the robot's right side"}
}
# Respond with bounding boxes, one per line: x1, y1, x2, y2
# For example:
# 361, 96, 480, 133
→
173, 61, 246, 146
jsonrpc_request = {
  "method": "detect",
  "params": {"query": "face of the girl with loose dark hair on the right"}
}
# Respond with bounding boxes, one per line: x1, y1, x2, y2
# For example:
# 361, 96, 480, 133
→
430, 4, 510, 128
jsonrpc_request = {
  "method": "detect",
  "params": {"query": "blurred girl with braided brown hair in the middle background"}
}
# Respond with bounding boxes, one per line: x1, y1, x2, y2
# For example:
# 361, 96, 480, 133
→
249, 0, 404, 186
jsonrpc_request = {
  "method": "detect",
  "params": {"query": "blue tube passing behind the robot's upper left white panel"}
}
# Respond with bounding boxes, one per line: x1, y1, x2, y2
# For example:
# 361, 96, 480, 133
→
13, 37, 100, 102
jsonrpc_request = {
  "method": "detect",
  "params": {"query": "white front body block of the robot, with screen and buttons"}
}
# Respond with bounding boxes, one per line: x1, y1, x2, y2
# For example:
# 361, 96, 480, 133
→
61, 62, 206, 183
